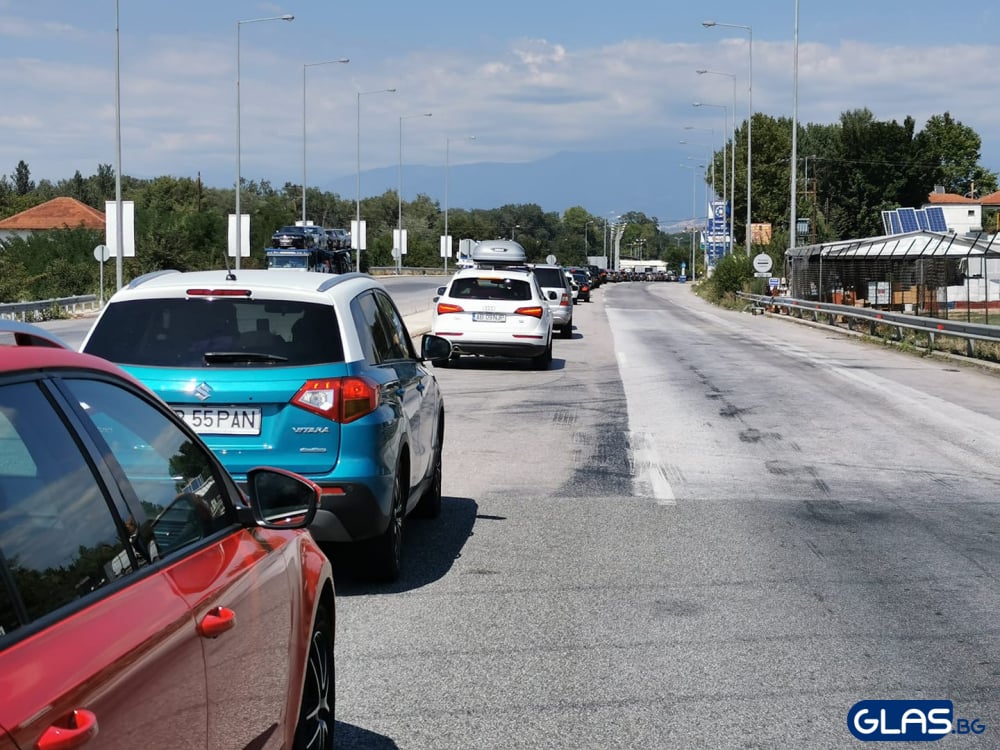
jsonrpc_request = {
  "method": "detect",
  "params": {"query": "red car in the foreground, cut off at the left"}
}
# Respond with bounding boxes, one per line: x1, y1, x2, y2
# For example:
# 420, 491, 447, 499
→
0, 321, 334, 750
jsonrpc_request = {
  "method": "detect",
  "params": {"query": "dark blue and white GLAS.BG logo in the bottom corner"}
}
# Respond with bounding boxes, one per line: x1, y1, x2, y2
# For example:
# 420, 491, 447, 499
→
847, 700, 986, 742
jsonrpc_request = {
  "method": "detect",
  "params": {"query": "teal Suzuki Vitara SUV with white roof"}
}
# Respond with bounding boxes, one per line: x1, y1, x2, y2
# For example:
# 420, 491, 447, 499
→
82, 270, 451, 581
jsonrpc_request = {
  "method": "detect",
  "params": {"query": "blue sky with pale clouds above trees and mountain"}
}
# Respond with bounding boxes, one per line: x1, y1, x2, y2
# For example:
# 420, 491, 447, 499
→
0, 0, 1000, 226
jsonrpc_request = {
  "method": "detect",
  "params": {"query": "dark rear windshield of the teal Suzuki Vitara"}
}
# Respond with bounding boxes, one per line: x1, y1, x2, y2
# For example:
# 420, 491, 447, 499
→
84, 298, 344, 367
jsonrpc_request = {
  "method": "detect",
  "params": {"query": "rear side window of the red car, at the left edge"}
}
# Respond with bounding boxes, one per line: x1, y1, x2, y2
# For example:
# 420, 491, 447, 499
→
0, 383, 140, 636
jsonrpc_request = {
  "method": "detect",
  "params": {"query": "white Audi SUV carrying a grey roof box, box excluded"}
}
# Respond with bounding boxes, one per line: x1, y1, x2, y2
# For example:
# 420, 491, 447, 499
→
431, 267, 553, 370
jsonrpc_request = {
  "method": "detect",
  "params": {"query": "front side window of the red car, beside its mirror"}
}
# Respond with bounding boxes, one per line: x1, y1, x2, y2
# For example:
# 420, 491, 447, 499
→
66, 379, 235, 559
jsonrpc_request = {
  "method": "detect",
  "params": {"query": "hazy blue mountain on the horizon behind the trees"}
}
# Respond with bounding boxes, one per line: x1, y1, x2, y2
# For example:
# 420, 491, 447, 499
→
319, 149, 705, 224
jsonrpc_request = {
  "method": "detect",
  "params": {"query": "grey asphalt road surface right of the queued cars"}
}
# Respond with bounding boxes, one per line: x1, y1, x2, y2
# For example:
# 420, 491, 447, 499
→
334, 283, 1000, 749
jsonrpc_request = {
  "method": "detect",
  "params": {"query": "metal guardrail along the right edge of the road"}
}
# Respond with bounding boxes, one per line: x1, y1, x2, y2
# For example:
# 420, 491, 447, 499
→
738, 292, 1000, 358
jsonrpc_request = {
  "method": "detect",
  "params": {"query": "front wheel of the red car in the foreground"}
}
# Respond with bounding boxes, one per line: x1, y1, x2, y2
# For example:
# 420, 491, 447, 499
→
294, 605, 335, 750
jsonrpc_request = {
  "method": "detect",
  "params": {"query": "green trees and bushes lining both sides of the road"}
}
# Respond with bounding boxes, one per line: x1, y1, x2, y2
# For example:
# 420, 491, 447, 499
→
0, 109, 1000, 305
